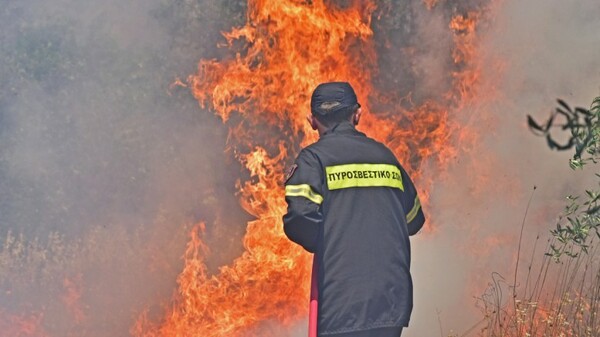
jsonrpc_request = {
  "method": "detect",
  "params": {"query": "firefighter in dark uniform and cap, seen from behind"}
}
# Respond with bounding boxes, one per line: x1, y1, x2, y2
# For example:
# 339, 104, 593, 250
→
283, 82, 425, 337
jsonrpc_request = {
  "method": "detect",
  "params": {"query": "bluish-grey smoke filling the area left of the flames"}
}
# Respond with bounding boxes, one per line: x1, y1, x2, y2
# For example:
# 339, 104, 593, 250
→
0, 0, 249, 336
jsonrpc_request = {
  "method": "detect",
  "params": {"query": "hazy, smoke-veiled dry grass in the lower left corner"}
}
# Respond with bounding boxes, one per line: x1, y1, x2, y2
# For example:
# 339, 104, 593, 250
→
0, 214, 187, 336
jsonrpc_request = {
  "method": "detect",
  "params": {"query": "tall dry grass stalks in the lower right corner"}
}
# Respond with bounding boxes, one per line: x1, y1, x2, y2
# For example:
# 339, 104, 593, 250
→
474, 236, 600, 337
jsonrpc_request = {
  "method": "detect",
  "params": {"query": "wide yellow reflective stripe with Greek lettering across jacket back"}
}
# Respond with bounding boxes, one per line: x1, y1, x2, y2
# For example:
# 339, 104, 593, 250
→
325, 164, 404, 191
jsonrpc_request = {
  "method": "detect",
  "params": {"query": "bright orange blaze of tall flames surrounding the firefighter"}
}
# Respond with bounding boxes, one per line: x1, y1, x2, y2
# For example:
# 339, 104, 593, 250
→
133, 0, 488, 337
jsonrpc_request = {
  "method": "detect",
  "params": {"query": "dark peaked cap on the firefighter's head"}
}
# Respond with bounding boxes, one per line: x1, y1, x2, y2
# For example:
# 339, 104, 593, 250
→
310, 82, 360, 117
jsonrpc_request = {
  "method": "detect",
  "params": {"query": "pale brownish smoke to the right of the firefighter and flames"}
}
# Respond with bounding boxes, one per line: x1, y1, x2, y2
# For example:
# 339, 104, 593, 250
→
406, 0, 600, 336
